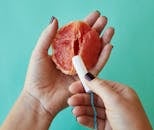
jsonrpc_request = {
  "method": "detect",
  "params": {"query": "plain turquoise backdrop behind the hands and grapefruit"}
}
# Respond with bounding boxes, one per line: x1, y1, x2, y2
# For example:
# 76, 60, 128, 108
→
0, 0, 154, 130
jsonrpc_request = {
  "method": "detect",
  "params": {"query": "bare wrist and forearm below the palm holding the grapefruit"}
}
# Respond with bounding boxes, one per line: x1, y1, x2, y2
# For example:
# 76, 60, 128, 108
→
1, 90, 53, 130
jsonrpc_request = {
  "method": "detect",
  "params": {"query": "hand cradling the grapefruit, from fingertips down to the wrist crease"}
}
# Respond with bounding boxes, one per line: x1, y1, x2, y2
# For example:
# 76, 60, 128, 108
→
24, 11, 114, 117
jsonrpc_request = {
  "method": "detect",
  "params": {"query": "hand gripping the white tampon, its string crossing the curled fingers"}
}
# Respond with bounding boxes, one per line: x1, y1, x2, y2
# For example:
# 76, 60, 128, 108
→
68, 78, 152, 130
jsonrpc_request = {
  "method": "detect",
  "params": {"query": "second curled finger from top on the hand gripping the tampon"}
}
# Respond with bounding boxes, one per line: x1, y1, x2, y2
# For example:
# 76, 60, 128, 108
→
68, 93, 104, 107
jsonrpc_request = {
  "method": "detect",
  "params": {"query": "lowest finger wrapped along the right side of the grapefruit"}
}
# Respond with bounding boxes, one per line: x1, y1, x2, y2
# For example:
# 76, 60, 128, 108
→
90, 44, 113, 75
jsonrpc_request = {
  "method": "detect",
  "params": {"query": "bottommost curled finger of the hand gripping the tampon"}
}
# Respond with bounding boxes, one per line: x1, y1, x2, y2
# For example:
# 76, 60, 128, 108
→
77, 116, 105, 130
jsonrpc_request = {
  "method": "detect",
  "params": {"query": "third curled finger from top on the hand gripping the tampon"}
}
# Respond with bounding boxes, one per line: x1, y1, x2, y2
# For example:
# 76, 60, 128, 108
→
72, 106, 106, 120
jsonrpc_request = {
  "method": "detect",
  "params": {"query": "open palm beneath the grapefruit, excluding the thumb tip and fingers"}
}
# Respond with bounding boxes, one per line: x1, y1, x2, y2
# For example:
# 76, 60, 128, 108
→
25, 50, 76, 114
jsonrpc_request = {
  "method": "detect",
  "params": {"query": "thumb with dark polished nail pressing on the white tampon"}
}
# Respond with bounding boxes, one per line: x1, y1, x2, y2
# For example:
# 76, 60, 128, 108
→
85, 73, 120, 105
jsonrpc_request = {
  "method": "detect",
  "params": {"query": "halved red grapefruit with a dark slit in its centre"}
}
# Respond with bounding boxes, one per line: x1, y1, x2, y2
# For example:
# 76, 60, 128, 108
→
51, 21, 102, 75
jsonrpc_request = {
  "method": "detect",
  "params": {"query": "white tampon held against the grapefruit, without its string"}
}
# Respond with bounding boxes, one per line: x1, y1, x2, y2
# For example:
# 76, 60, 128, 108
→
72, 55, 91, 93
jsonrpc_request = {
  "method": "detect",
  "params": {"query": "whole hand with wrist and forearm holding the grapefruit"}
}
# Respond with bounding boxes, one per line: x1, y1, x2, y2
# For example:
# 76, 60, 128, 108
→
1, 11, 114, 130
